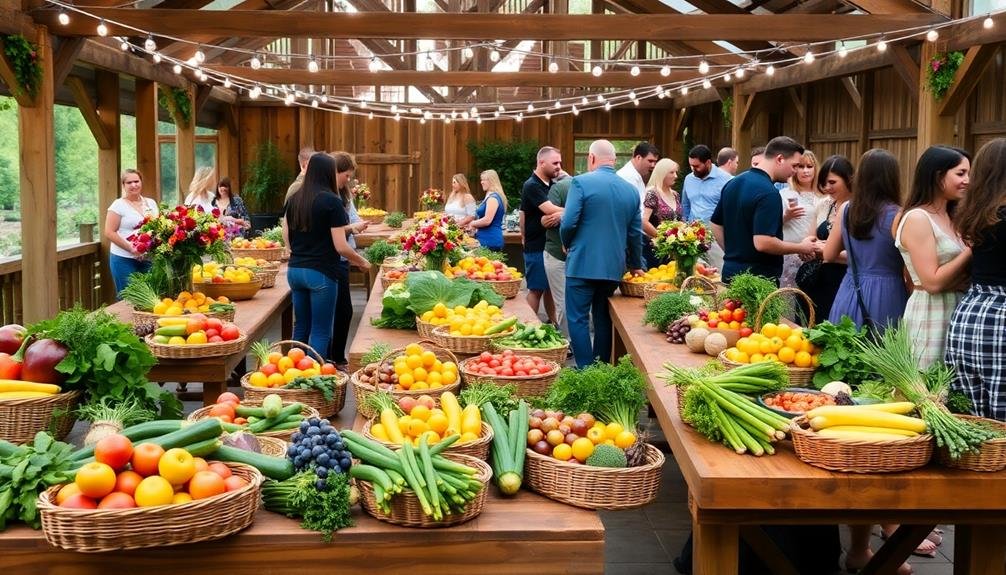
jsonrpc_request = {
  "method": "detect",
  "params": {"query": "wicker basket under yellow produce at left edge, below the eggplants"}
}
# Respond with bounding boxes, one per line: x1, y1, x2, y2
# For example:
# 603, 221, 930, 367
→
0, 390, 80, 443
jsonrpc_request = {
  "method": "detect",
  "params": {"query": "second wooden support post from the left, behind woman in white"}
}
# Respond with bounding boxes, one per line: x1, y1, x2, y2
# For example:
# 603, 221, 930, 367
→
95, 69, 122, 304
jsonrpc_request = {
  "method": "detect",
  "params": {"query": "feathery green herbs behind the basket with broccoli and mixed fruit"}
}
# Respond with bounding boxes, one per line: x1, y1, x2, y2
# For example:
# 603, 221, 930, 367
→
545, 356, 649, 430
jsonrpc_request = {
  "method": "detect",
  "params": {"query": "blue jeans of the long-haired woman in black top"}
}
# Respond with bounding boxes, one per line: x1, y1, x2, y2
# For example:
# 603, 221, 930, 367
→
287, 267, 339, 354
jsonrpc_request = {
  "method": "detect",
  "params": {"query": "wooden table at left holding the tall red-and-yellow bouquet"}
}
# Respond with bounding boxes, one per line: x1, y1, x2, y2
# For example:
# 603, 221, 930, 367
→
107, 265, 294, 405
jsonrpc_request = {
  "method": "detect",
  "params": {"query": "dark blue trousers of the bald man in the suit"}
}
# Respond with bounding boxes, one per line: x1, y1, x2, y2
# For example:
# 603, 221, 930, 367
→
565, 276, 619, 367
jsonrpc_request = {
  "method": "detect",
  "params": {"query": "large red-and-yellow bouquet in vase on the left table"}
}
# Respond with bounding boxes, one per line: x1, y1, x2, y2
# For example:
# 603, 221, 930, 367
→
127, 206, 227, 297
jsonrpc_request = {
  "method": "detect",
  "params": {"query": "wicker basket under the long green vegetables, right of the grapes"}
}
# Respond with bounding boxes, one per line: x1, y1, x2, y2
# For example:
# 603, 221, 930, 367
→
356, 452, 493, 528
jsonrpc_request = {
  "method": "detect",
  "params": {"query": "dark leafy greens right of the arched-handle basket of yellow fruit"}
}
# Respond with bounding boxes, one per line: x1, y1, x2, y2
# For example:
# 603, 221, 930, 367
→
808, 316, 883, 399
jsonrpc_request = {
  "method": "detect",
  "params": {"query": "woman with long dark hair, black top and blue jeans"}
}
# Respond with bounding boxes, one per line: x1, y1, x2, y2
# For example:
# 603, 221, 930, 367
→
281, 153, 370, 354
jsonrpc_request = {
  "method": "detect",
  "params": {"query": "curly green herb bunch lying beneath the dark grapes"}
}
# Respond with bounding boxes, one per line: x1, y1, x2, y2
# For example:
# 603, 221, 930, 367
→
262, 471, 354, 543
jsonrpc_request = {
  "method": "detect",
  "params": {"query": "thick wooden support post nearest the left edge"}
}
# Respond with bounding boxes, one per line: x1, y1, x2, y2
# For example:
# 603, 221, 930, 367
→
17, 26, 59, 325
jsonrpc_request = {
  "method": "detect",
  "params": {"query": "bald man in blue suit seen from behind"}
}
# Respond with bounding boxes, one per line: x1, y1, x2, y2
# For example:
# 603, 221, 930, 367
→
559, 140, 643, 367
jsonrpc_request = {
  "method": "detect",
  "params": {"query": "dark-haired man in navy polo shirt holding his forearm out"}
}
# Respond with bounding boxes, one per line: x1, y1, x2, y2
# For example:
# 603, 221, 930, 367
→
712, 136, 814, 282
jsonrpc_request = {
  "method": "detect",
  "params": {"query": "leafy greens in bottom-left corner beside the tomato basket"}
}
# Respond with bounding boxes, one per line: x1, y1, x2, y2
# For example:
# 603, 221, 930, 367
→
0, 431, 73, 531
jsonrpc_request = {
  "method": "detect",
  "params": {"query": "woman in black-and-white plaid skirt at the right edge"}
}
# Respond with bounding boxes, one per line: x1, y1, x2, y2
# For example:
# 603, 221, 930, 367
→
946, 138, 1006, 421
